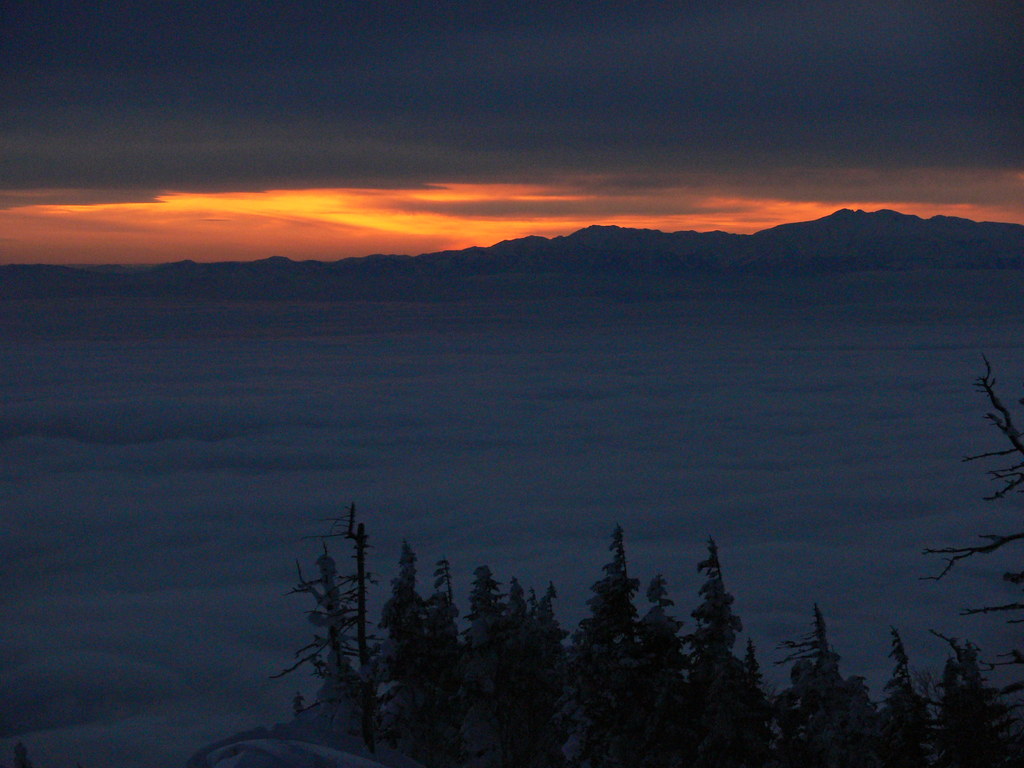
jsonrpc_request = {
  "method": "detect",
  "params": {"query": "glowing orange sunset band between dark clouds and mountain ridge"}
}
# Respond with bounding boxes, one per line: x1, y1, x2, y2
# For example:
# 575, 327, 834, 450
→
0, 184, 1020, 263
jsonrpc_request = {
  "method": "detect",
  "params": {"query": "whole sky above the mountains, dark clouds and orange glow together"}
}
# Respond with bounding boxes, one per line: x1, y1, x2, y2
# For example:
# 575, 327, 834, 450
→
0, 0, 1024, 263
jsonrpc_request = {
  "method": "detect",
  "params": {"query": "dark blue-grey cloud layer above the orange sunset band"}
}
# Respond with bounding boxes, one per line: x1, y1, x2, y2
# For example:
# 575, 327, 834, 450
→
0, 0, 1024, 199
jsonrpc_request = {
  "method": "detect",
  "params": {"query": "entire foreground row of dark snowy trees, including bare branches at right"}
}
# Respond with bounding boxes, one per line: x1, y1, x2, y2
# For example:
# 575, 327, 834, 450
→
280, 359, 1024, 768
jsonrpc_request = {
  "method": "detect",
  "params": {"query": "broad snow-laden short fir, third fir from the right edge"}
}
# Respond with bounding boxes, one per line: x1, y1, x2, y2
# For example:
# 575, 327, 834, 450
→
776, 605, 881, 768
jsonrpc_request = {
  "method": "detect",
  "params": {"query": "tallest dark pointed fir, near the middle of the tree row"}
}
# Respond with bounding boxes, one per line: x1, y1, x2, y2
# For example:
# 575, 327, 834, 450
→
565, 525, 647, 768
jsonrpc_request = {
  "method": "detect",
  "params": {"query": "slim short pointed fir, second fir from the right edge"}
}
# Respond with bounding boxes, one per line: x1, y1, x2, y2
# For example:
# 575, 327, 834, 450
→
879, 628, 932, 768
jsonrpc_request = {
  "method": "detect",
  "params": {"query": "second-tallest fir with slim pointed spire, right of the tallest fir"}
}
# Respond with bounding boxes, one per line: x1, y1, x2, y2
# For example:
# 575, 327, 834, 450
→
686, 539, 769, 768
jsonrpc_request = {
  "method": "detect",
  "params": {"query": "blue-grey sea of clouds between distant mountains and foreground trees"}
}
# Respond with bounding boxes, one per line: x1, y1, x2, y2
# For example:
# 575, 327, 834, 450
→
0, 272, 1024, 768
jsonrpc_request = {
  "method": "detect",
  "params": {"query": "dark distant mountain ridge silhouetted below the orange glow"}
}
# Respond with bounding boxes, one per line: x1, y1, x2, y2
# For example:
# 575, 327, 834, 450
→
0, 209, 1024, 300
